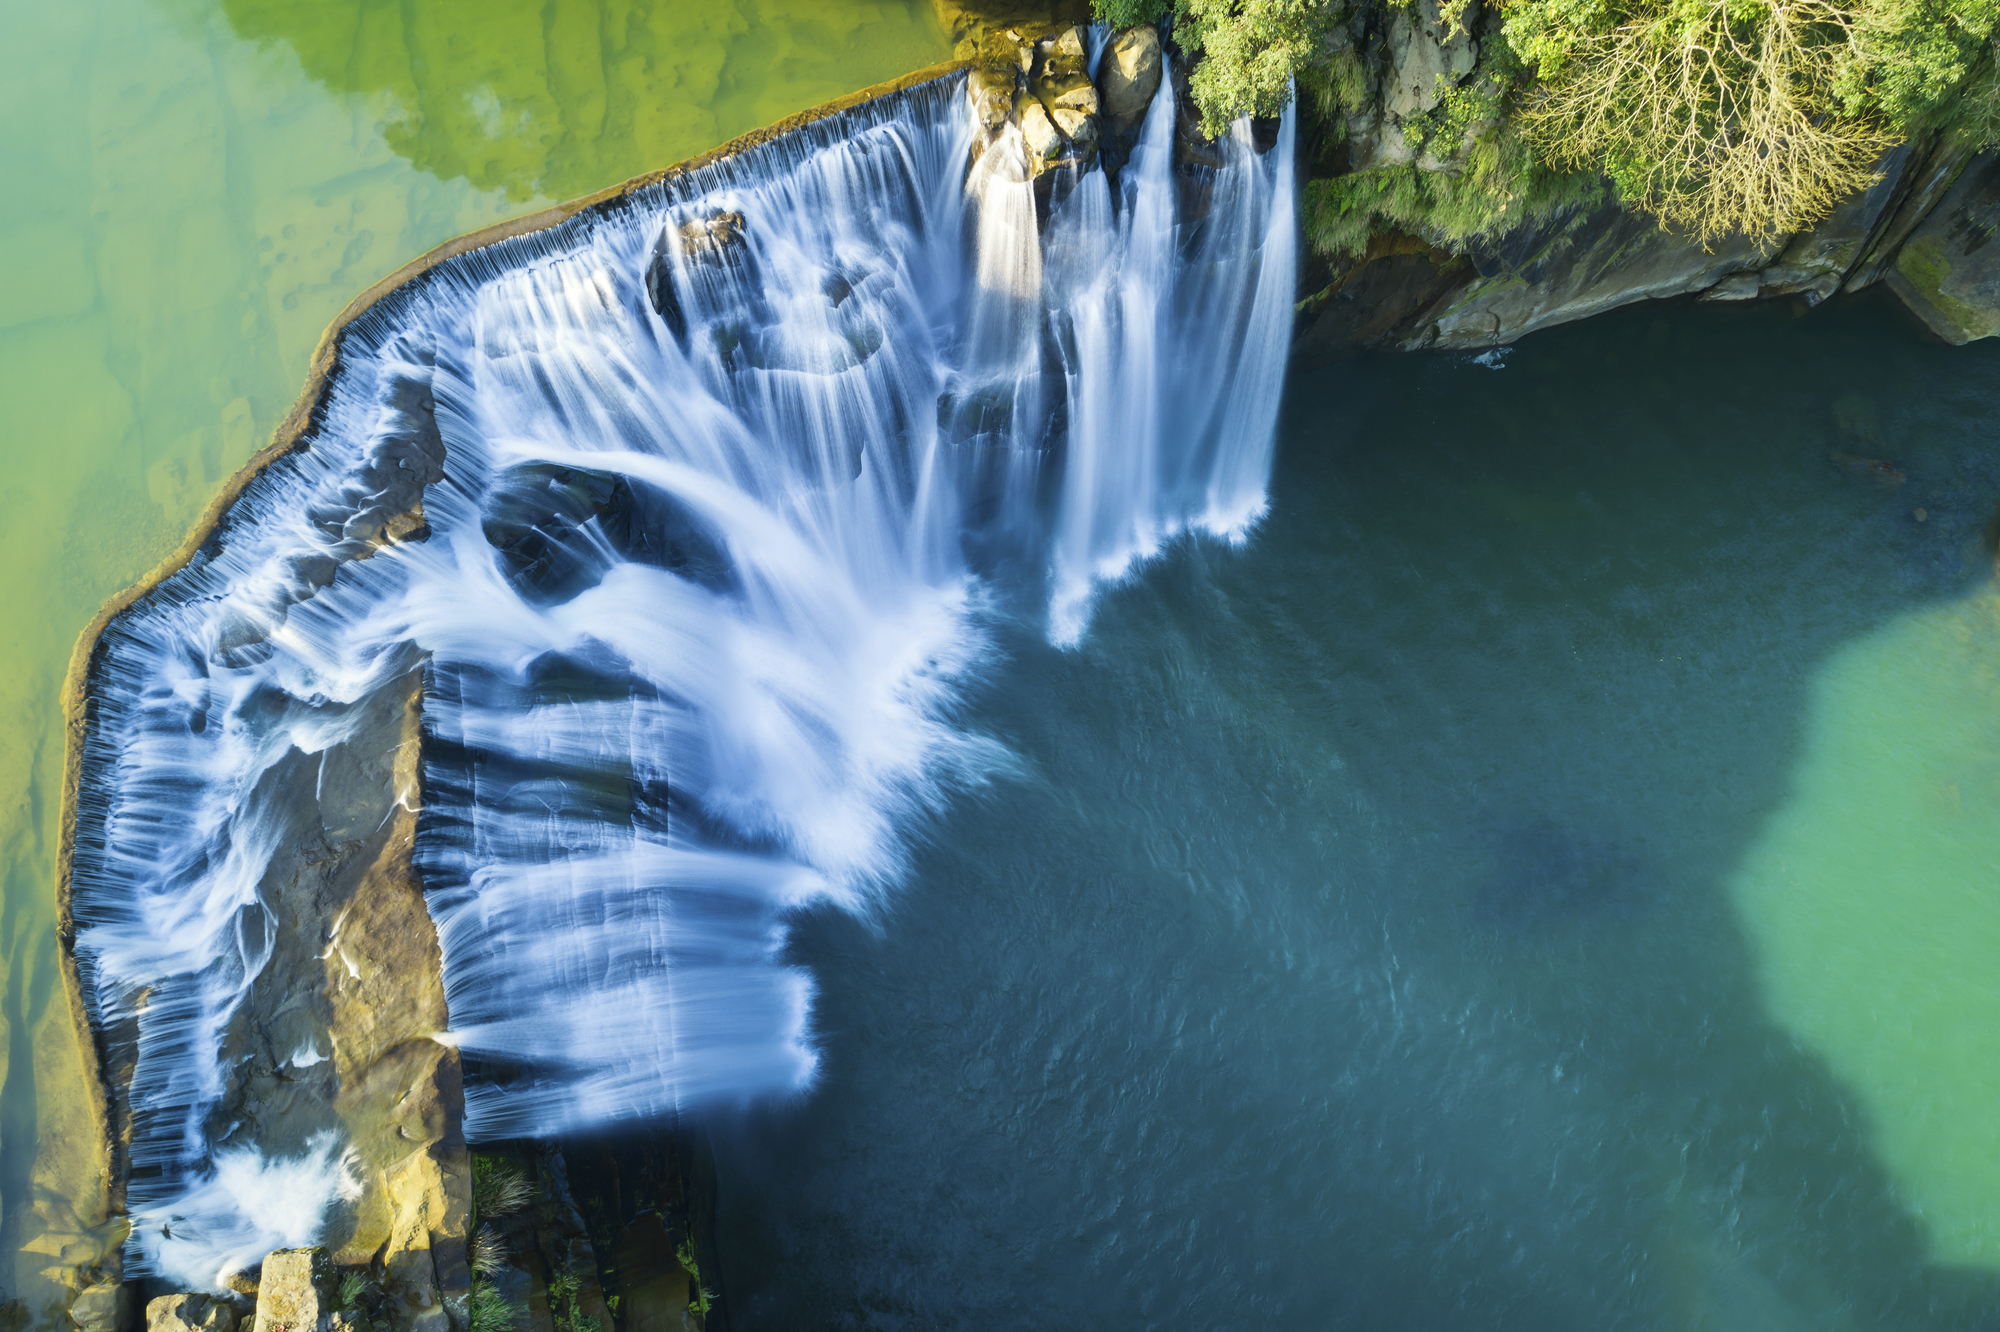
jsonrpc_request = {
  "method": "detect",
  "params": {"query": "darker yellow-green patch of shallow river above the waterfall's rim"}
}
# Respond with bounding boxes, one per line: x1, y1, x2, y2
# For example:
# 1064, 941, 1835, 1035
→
220, 0, 952, 204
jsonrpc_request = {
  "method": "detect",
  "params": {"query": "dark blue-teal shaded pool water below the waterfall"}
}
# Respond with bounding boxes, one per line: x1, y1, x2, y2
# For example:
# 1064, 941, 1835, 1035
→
710, 300, 2000, 1332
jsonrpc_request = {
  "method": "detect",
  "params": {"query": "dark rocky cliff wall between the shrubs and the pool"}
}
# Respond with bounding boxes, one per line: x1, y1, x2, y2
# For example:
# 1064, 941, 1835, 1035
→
1296, 0, 2000, 360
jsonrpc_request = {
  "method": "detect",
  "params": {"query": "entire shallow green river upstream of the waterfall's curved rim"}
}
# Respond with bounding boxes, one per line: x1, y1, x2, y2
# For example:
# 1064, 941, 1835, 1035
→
0, 0, 950, 1322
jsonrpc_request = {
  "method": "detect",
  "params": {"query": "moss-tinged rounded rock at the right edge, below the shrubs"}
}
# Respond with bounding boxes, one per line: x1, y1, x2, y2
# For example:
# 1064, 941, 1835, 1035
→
1886, 152, 2000, 344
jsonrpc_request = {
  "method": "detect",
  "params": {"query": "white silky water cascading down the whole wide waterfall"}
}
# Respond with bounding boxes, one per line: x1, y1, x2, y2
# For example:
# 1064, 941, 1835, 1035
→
62, 62, 1294, 1284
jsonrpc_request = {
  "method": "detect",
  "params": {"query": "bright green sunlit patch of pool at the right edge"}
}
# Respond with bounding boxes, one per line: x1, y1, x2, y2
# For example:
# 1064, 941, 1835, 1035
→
1732, 590, 2000, 1268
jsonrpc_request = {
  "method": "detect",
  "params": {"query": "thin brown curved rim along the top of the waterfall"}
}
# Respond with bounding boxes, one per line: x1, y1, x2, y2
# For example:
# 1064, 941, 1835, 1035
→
56, 60, 972, 1332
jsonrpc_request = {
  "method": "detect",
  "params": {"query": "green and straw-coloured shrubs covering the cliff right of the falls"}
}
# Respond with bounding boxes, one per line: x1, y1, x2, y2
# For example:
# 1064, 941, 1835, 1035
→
1096, 0, 2000, 250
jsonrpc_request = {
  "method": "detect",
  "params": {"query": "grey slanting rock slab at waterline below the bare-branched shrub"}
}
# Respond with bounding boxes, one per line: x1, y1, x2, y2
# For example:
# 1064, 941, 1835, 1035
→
1404, 204, 1784, 350
